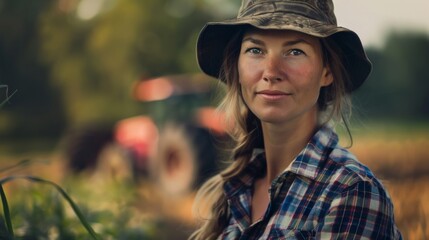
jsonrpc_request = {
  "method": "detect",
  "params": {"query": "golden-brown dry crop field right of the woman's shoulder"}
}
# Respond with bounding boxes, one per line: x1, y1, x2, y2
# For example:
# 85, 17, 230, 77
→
351, 124, 429, 240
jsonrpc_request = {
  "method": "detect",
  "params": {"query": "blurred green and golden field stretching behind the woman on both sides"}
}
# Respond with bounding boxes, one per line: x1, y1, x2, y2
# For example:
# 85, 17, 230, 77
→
0, 125, 429, 239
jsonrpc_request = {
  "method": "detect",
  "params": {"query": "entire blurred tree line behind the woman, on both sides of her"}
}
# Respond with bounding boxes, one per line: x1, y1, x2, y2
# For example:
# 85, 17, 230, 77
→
0, 0, 429, 140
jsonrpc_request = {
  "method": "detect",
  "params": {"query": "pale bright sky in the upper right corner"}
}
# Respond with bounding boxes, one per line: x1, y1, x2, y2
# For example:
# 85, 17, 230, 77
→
333, 0, 429, 47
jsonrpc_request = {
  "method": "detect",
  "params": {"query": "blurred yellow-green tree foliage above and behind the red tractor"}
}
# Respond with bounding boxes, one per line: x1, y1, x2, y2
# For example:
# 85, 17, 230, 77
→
39, 0, 237, 124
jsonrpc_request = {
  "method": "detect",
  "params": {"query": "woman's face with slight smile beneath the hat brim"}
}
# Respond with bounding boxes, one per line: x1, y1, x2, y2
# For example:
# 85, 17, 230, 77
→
238, 30, 333, 124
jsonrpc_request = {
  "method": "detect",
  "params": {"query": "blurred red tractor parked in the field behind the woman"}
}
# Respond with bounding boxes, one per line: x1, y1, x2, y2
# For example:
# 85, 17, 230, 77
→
65, 74, 230, 194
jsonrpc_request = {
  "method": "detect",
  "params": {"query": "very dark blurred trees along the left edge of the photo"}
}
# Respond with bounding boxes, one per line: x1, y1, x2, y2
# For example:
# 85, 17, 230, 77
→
0, 0, 67, 141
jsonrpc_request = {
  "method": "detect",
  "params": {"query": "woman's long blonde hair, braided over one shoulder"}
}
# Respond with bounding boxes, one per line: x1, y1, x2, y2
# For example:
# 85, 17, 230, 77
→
190, 28, 351, 240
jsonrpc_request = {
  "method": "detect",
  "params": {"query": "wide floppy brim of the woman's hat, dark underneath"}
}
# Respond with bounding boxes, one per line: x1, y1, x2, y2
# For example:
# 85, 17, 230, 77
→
197, 14, 372, 92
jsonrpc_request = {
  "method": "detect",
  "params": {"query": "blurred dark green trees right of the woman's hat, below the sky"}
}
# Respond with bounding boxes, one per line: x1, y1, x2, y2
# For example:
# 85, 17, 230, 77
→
355, 32, 429, 120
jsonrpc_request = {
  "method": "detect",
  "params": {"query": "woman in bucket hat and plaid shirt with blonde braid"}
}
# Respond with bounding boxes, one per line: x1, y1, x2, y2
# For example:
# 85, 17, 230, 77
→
192, 0, 401, 239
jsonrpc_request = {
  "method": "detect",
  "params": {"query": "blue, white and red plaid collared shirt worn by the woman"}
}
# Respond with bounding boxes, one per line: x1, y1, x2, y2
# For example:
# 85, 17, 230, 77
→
218, 127, 402, 239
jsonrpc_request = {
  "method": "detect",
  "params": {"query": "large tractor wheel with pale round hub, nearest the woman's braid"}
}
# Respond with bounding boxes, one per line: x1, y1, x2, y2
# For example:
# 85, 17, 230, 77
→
151, 124, 226, 195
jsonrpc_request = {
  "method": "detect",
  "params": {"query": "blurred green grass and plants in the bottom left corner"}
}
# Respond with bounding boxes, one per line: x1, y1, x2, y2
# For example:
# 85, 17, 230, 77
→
0, 158, 157, 240
